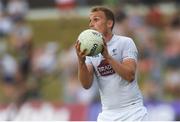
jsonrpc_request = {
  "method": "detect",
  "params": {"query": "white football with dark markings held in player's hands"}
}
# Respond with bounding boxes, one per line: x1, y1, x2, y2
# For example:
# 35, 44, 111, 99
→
78, 29, 103, 56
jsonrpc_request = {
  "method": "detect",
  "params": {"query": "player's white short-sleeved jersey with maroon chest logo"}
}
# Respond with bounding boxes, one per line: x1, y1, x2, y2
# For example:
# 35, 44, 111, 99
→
86, 35, 143, 110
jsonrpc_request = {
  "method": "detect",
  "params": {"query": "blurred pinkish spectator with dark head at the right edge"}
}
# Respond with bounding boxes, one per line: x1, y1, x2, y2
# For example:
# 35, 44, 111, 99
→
164, 15, 180, 69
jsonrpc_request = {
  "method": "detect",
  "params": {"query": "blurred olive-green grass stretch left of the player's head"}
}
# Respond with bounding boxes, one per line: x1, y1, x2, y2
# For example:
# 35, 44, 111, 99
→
29, 18, 88, 49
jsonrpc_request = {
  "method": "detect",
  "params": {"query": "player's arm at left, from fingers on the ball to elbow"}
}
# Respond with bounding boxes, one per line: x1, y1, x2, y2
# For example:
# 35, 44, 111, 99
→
75, 41, 93, 89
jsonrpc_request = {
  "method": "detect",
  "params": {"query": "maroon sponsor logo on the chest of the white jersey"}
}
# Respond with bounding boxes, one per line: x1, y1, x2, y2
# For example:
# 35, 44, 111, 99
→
97, 60, 115, 76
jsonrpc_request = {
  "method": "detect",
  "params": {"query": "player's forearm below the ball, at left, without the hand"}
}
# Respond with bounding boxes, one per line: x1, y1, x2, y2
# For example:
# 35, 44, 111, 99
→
78, 62, 93, 89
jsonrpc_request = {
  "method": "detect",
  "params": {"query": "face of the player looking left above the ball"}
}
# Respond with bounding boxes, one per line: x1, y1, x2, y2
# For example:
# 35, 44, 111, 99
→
89, 11, 109, 34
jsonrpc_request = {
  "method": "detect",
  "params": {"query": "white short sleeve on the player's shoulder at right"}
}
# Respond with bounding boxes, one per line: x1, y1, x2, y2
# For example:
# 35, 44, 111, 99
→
122, 38, 138, 62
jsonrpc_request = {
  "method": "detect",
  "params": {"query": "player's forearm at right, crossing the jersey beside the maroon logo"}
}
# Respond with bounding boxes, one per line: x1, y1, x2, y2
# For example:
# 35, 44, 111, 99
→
107, 57, 135, 82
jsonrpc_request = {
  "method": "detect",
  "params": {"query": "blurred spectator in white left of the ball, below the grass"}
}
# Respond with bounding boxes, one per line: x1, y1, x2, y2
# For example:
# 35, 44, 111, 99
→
32, 42, 58, 77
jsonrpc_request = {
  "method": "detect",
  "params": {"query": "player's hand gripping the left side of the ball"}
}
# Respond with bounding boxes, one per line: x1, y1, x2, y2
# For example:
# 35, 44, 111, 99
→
75, 41, 86, 63
